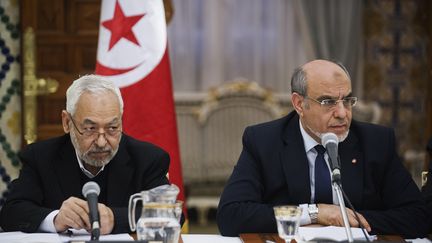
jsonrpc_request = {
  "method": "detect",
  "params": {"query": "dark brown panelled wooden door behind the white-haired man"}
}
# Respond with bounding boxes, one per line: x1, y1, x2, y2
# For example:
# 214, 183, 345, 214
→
20, 0, 101, 140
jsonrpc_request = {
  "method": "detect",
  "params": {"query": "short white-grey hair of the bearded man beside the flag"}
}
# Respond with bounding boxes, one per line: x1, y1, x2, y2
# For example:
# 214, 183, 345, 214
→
66, 74, 123, 115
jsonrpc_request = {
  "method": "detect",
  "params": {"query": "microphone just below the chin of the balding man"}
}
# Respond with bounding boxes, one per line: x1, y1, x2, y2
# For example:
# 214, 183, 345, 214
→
321, 132, 341, 183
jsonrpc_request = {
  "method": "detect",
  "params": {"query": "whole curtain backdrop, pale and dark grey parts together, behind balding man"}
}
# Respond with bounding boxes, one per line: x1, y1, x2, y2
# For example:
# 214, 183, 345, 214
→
168, 0, 363, 95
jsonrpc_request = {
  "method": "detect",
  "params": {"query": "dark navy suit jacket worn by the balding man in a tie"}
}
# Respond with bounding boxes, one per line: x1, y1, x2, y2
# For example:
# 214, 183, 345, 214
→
217, 112, 427, 237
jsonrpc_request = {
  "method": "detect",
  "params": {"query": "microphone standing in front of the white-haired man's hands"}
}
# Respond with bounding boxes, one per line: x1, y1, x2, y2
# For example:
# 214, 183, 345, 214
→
82, 181, 100, 240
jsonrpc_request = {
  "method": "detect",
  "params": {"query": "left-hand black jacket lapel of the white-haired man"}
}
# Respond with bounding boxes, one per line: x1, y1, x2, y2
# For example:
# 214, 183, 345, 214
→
53, 135, 83, 199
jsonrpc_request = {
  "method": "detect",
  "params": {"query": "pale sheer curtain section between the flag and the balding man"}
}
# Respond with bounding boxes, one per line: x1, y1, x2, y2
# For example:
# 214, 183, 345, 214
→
168, 0, 306, 92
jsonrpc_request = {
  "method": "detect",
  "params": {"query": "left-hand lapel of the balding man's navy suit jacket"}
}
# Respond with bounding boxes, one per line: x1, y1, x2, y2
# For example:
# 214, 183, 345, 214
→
280, 115, 311, 203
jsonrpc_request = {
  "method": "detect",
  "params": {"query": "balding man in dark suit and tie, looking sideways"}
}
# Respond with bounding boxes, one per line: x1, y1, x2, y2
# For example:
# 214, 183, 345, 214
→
217, 60, 427, 237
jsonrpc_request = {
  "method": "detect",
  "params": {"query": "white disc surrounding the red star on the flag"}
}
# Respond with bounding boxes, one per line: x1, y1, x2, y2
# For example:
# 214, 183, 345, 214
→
97, 0, 167, 88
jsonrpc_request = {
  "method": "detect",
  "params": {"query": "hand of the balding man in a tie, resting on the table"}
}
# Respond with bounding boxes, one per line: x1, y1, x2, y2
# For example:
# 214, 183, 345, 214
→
318, 204, 371, 232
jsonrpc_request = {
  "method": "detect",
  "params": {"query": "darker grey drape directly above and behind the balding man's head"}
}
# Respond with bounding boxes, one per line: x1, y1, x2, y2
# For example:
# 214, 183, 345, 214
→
292, 0, 364, 97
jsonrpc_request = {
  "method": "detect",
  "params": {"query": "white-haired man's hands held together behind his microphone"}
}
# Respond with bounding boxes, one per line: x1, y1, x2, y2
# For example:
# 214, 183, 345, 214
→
54, 197, 114, 235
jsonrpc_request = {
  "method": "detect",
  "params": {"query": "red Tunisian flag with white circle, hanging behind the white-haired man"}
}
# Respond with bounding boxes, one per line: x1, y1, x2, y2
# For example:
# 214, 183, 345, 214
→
96, 0, 184, 205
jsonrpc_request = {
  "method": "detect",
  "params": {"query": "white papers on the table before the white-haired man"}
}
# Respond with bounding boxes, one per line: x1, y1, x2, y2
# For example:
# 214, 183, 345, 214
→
0, 230, 133, 243
